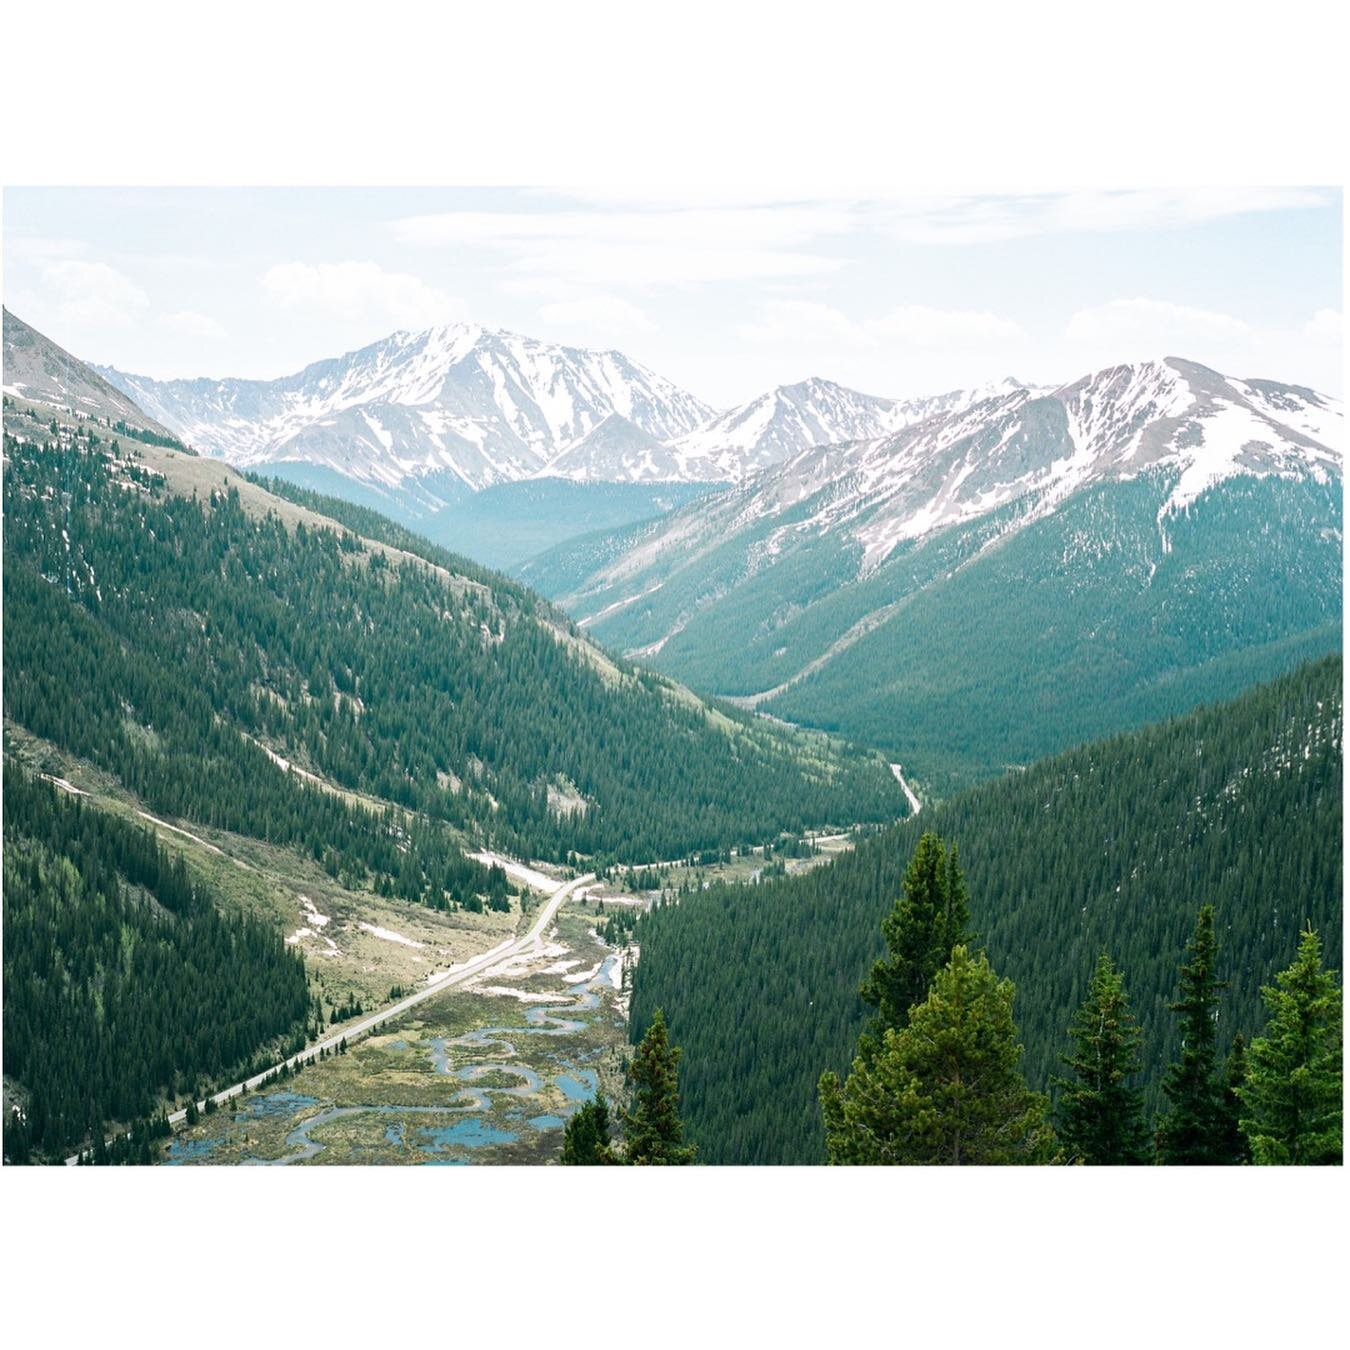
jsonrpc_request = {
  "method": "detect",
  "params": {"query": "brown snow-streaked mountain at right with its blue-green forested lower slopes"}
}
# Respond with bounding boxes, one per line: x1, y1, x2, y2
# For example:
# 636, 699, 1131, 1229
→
534, 359, 1342, 792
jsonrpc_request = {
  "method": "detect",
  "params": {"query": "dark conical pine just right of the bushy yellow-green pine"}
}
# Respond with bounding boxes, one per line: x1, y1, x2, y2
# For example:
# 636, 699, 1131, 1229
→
1056, 952, 1150, 1166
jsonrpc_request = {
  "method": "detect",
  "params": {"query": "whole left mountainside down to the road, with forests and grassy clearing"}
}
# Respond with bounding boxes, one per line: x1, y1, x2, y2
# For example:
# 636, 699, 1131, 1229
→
0, 315, 906, 1164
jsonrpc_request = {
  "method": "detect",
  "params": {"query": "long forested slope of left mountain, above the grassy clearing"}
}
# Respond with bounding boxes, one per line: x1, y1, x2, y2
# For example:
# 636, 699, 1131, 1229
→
4, 415, 903, 874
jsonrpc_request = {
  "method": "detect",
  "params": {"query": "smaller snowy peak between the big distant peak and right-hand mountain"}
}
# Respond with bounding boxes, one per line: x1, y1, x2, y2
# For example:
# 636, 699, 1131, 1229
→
658, 379, 1023, 482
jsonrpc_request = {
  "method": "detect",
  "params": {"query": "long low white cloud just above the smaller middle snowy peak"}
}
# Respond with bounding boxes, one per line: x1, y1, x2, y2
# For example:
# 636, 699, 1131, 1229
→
740, 300, 1022, 351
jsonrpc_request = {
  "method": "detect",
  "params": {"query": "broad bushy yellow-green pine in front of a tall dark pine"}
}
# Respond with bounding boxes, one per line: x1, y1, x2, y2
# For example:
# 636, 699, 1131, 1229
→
819, 945, 1054, 1165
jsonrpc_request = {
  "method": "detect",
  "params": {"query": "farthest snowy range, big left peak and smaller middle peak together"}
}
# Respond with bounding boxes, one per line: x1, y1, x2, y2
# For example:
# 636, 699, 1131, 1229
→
97, 324, 1022, 496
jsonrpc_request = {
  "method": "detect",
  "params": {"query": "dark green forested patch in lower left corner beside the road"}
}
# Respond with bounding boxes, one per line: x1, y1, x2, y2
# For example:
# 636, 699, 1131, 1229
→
4, 760, 311, 1161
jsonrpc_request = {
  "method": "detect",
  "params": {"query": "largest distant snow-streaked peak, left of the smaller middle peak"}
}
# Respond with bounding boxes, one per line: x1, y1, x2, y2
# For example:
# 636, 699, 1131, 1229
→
101, 324, 713, 502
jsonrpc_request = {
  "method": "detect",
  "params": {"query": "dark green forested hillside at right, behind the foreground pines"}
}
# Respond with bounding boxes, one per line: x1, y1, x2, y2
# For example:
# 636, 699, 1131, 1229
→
632, 656, 1342, 1162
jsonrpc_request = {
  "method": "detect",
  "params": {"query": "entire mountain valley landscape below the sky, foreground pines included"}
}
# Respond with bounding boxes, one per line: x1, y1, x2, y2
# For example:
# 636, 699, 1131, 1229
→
4, 298, 1343, 1165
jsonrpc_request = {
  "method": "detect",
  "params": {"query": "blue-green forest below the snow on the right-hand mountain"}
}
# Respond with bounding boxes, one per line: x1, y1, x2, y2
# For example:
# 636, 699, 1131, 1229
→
766, 477, 1341, 794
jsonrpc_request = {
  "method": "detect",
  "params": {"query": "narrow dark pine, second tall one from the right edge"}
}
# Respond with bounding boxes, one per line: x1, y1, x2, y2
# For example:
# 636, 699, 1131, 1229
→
1157, 905, 1233, 1166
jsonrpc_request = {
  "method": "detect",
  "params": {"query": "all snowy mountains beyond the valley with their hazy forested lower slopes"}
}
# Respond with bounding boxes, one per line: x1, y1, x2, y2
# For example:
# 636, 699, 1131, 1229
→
7, 306, 1343, 795
